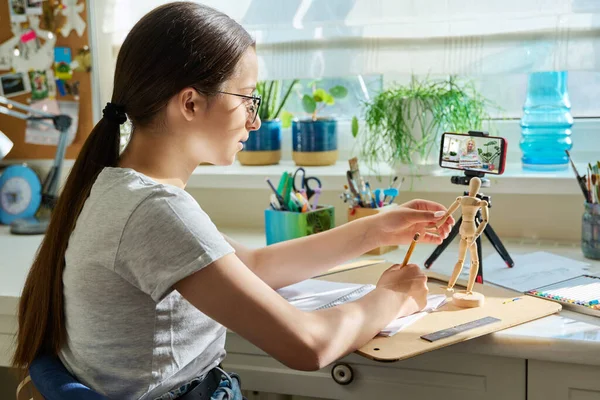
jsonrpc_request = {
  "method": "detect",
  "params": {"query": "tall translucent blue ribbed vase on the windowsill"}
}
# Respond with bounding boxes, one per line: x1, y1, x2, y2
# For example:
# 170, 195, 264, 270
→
520, 71, 573, 171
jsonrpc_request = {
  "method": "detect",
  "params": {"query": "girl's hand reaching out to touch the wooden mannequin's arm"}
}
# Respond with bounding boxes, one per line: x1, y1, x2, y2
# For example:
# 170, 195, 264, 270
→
373, 199, 454, 246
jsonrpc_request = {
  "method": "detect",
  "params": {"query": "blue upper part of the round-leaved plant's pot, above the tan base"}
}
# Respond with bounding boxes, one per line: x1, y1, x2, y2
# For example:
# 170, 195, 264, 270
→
292, 119, 337, 153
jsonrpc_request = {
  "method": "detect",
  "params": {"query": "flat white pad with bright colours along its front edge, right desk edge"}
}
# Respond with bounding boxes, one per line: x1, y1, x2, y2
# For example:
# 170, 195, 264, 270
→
525, 275, 600, 316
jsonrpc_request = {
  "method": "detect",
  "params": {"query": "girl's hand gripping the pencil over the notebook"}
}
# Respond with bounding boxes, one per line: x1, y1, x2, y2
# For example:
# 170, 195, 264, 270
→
377, 264, 429, 318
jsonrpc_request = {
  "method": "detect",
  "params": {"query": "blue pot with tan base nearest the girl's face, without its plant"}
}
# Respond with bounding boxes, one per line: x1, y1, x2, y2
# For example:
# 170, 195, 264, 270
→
237, 119, 281, 165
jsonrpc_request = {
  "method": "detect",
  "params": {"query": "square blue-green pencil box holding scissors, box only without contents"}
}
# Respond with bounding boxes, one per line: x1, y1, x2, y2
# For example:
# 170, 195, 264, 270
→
265, 205, 335, 246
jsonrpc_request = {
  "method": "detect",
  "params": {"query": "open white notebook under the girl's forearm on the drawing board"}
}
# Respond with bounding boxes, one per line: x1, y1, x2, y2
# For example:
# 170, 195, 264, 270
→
277, 279, 446, 336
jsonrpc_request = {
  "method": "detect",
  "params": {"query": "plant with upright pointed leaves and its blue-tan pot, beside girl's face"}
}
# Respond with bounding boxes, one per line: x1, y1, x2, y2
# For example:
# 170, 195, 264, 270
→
237, 80, 298, 165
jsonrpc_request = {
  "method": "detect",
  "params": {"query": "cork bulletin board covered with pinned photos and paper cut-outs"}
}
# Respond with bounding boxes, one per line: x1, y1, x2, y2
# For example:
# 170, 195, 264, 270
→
0, 0, 93, 160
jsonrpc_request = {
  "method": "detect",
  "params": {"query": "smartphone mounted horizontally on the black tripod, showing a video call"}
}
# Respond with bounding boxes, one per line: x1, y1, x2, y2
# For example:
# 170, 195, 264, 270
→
440, 132, 507, 175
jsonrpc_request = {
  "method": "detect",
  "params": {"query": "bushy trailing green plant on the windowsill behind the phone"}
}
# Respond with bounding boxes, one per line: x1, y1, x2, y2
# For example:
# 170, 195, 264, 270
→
352, 76, 496, 172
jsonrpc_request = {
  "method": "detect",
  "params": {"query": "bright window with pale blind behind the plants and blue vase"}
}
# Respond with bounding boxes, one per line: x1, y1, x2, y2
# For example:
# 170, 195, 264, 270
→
90, 0, 600, 167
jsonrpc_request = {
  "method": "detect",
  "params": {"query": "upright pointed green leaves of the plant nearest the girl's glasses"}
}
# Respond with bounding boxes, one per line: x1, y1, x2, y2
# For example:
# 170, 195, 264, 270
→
256, 79, 298, 128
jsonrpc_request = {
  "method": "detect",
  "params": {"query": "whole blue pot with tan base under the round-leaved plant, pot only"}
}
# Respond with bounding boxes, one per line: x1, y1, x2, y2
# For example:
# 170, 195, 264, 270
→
292, 119, 338, 166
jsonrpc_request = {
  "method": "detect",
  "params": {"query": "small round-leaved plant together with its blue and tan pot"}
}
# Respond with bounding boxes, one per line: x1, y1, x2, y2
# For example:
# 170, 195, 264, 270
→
292, 83, 348, 166
